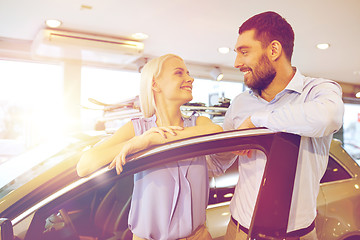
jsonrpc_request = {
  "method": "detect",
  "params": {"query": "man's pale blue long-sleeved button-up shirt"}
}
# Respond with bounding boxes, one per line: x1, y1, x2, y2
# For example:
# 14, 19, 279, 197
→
223, 70, 344, 232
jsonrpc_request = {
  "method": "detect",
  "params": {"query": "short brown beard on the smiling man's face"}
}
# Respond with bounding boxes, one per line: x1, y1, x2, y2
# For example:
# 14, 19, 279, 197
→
240, 54, 276, 94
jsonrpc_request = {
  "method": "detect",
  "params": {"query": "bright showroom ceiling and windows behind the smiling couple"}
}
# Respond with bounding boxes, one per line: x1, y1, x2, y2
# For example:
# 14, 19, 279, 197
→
0, 0, 360, 162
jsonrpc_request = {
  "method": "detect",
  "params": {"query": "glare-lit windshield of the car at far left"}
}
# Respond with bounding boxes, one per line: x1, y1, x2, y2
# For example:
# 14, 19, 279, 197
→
0, 133, 104, 199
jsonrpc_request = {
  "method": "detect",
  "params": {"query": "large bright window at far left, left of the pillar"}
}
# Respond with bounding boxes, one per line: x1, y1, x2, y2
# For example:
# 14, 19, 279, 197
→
0, 61, 64, 147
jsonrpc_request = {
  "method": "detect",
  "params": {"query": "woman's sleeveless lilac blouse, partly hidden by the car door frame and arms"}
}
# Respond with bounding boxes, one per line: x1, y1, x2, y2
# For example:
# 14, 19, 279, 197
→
129, 115, 209, 240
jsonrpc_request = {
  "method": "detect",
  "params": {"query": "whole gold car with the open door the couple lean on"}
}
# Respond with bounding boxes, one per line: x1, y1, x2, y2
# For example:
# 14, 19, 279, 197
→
0, 128, 360, 240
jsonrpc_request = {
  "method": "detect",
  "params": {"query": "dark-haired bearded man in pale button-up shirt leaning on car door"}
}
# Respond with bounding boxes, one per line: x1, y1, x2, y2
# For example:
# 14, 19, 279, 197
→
219, 12, 343, 239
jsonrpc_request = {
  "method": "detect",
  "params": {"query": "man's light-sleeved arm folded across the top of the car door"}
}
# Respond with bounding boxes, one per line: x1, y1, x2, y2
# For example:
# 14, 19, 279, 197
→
250, 82, 344, 137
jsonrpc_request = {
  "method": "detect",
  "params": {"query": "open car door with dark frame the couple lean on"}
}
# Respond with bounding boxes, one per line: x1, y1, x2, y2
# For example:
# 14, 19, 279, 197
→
0, 128, 300, 240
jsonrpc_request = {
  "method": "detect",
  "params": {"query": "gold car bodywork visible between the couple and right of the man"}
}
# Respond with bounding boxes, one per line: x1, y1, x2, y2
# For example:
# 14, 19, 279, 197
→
207, 139, 360, 240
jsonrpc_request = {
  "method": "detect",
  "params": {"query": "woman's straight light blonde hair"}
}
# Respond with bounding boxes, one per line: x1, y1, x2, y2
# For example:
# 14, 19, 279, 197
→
140, 54, 183, 118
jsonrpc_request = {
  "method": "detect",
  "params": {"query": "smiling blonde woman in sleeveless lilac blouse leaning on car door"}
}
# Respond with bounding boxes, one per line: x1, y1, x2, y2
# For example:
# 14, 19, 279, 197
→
77, 54, 222, 240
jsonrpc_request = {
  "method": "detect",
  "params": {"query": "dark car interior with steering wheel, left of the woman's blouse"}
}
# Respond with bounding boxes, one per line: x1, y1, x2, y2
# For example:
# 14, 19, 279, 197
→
25, 172, 133, 240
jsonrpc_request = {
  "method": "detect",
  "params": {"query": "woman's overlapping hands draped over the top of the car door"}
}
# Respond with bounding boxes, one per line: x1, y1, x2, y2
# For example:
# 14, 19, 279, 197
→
109, 126, 184, 174
